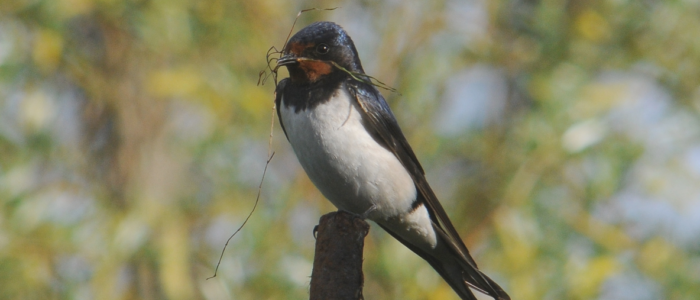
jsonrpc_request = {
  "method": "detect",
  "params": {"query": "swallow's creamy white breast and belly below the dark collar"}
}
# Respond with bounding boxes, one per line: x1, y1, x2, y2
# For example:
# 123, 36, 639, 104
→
279, 89, 416, 221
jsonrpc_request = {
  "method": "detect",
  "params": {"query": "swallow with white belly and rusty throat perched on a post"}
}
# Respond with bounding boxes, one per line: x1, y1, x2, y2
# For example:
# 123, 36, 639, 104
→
275, 22, 510, 300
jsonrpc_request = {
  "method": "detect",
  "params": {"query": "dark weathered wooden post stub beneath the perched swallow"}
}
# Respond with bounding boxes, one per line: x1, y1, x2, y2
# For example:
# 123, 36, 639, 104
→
310, 211, 369, 300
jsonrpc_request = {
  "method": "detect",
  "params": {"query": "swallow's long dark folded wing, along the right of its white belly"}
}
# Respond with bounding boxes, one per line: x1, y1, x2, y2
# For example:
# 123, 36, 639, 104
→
346, 80, 510, 299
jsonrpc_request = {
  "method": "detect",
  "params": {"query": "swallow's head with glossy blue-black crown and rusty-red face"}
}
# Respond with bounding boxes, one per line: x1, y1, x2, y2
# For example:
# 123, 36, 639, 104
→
279, 22, 364, 83
